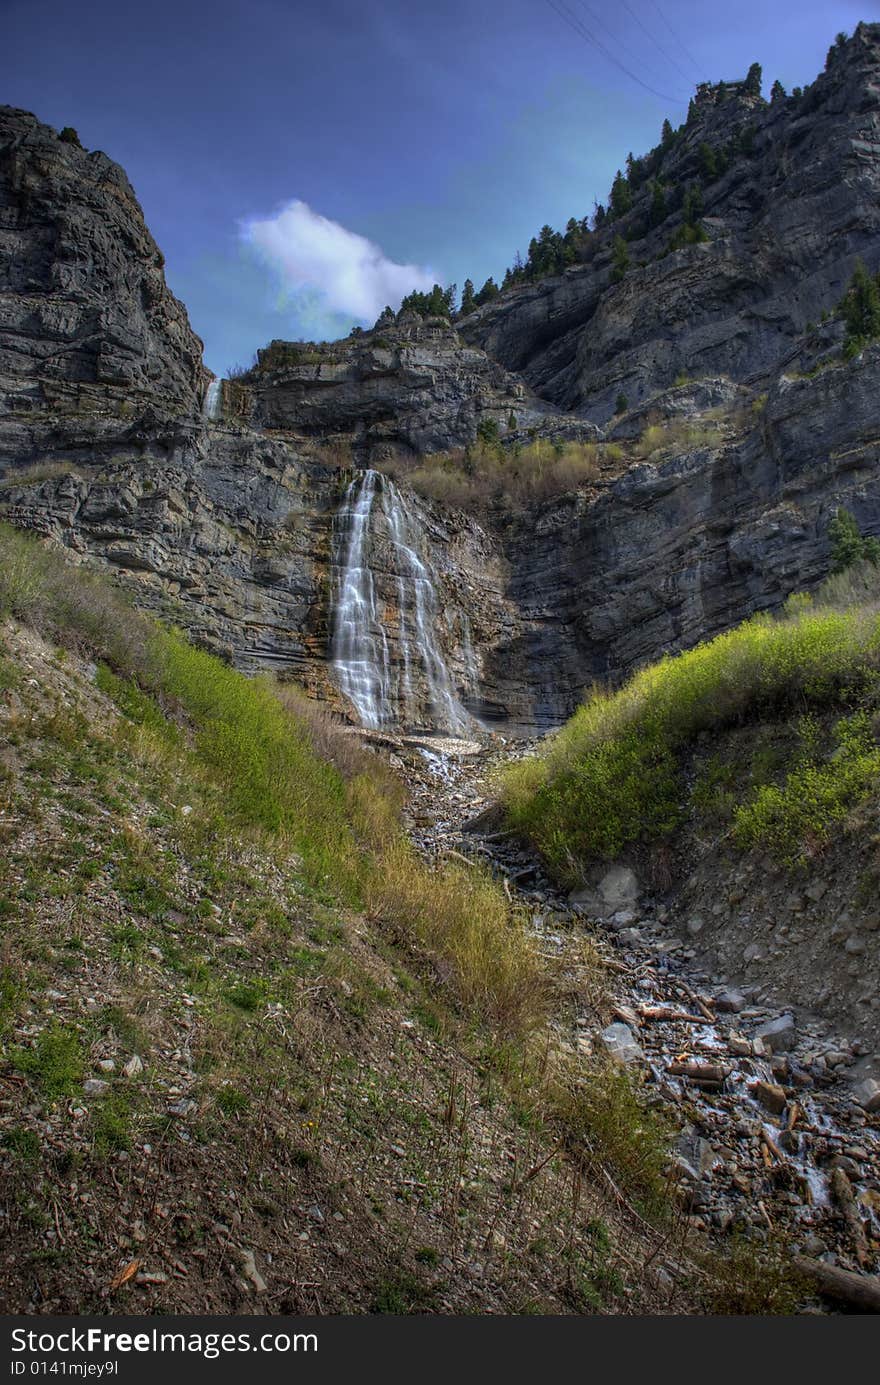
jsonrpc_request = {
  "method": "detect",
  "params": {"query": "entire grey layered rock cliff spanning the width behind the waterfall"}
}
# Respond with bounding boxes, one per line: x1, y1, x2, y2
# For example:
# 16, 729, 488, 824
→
0, 25, 880, 729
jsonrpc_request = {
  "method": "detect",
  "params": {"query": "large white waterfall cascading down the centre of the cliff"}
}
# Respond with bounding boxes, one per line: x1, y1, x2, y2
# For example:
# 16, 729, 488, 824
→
331, 471, 475, 733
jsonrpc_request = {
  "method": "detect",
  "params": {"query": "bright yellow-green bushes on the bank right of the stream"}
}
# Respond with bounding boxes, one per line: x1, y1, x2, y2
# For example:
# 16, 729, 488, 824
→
500, 605, 880, 882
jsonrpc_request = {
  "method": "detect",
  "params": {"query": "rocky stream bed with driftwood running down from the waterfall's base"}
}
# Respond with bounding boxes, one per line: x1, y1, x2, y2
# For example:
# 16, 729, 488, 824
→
385, 737, 880, 1273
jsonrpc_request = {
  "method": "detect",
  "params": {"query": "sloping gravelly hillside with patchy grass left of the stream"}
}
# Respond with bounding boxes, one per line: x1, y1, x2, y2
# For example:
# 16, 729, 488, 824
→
0, 529, 705, 1313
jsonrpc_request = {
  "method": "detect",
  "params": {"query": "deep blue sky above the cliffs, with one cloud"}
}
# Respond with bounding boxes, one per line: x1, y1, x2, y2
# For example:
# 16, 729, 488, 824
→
0, 0, 880, 373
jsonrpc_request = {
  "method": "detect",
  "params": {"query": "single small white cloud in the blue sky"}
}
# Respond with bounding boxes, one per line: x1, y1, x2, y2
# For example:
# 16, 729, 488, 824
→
241, 201, 434, 323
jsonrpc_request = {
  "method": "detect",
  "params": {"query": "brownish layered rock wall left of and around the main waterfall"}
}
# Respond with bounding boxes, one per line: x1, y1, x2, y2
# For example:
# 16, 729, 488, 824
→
0, 425, 528, 731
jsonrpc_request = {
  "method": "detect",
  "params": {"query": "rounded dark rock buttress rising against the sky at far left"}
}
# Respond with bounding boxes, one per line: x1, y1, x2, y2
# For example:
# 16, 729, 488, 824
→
0, 107, 208, 479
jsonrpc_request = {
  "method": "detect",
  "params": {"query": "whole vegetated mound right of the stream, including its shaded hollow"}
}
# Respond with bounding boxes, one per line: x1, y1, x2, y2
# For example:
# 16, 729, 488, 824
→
500, 561, 880, 884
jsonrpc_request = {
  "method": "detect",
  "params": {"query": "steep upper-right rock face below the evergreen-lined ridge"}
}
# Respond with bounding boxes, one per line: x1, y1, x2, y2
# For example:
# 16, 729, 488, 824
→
460, 25, 880, 424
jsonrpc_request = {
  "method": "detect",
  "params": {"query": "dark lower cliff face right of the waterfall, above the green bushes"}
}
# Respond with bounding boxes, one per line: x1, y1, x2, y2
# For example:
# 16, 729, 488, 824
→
491, 346, 880, 727
